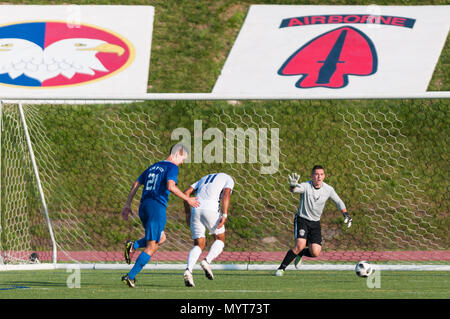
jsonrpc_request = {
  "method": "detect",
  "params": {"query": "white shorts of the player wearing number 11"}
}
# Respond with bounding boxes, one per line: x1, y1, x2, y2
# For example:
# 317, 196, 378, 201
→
191, 208, 225, 239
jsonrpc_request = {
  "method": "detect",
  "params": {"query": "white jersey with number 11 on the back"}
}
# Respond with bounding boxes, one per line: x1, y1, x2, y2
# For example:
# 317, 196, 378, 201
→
191, 173, 234, 212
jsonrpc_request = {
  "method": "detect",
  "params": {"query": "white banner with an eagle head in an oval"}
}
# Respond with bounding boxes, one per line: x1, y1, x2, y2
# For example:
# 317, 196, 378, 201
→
0, 5, 154, 98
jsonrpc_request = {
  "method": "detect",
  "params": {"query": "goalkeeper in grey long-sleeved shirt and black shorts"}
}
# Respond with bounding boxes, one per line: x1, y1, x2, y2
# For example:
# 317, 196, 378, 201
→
275, 165, 352, 276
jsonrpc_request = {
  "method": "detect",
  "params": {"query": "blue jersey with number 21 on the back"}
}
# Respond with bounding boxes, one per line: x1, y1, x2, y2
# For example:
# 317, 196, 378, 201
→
137, 161, 178, 207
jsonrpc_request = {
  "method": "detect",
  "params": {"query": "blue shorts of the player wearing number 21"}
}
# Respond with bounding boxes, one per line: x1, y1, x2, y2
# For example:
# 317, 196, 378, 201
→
139, 199, 167, 242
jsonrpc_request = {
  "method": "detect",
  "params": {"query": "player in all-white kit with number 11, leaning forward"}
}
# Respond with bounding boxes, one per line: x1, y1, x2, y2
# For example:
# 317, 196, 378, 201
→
184, 173, 234, 287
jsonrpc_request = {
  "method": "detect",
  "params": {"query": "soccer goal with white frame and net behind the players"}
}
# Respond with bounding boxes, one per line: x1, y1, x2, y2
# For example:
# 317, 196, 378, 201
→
0, 94, 450, 270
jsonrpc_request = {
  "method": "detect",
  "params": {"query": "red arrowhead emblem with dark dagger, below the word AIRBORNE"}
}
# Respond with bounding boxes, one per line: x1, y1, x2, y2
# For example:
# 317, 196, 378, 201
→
278, 26, 378, 88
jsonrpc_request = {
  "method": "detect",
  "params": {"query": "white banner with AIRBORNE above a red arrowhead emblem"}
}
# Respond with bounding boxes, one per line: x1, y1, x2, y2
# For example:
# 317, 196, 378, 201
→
213, 5, 450, 98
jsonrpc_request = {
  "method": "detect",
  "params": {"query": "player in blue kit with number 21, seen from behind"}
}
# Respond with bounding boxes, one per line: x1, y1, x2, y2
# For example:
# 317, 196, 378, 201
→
122, 144, 199, 288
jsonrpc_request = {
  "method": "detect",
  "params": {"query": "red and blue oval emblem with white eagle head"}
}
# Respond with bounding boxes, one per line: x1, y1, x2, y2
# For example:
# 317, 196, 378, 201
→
0, 21, 134, 88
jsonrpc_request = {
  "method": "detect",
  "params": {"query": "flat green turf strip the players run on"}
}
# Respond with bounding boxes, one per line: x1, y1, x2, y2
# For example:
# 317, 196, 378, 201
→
0, 270, 450, 299
